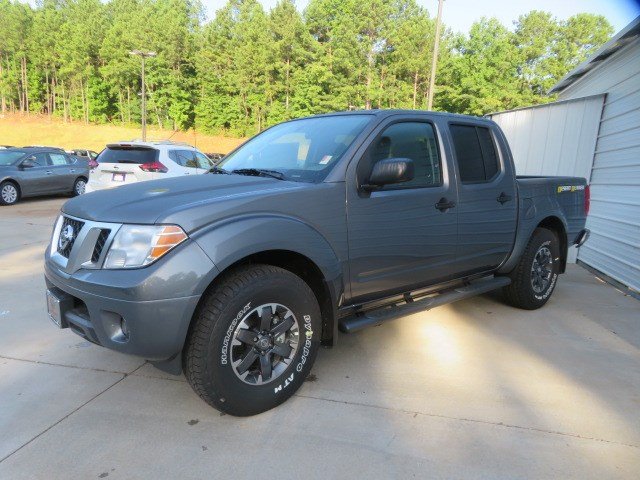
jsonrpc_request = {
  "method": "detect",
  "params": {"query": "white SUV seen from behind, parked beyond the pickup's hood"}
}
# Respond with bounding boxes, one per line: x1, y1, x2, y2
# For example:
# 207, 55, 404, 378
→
86, 141, 214, 192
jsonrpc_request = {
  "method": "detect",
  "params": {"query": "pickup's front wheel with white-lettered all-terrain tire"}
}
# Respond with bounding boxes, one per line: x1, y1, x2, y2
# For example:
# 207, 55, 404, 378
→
183, 265, 321, 416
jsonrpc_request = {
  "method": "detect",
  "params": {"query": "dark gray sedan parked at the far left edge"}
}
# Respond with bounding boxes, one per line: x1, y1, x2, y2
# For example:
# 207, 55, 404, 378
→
0, 148, 89, 205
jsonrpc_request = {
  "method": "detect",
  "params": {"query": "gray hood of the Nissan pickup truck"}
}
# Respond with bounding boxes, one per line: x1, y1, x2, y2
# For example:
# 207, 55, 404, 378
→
62, 174, 309, 228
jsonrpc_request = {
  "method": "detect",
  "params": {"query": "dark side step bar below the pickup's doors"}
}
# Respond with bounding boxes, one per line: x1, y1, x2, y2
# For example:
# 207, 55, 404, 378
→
338, 277, 511, 333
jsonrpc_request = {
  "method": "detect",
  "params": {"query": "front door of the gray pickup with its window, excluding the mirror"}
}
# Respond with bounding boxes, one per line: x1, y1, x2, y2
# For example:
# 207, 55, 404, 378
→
347, 119, 457, 302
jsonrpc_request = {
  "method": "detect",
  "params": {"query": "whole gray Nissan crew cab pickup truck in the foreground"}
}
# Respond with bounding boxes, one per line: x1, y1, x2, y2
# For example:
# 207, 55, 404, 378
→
45, 111, 589, 415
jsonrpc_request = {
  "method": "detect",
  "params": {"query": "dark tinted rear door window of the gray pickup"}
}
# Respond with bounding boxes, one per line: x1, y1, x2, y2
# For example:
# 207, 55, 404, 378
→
450, 125, 500, 183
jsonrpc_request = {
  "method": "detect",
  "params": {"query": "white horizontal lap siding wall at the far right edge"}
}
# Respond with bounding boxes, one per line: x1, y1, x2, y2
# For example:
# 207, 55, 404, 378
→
560, 39, 640, 291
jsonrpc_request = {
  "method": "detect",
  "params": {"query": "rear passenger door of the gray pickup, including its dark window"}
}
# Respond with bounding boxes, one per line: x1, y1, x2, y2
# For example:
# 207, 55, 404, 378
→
449, 123, 518, 274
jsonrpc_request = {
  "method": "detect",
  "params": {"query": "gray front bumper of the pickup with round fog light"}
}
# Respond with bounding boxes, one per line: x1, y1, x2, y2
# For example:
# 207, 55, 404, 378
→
45, 241, 217, 362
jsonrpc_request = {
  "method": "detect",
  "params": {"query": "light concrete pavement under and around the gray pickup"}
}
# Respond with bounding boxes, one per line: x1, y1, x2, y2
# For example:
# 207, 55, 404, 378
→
0, 198, 640, 480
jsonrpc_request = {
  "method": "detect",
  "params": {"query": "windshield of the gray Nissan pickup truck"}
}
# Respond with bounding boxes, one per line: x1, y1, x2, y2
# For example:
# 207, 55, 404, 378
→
218, 114, 372, 182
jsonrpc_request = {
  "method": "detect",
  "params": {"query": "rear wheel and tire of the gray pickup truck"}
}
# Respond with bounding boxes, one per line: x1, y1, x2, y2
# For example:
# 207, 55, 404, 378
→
503, 228, 560, 310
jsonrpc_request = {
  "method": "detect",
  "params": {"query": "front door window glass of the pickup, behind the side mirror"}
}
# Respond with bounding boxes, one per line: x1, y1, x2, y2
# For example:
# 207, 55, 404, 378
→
362, 122, 442, 190
